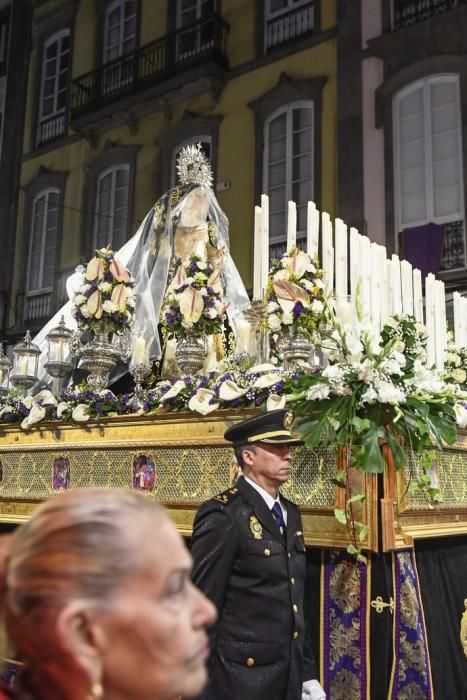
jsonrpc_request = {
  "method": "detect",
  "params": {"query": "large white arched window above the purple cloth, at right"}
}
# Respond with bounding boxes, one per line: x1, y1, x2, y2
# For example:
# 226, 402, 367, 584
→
393, 75, 465, 269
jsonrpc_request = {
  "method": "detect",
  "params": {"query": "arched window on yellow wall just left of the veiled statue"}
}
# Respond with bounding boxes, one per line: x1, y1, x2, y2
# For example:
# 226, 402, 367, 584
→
92, 164, 130, 250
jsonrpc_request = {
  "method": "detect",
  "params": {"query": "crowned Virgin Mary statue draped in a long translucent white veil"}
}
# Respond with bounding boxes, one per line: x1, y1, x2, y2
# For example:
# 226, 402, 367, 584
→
34, 144, 250, 379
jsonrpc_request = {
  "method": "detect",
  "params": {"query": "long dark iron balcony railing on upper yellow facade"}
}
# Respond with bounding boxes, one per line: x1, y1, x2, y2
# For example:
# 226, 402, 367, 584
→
71, 14, 229, 120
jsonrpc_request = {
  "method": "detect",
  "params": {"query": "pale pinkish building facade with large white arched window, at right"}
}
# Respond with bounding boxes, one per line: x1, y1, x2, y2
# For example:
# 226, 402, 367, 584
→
362, 0, 467, 298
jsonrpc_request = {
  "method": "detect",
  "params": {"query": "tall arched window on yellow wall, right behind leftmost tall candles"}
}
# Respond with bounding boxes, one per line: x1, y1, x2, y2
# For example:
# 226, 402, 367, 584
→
263, 101, 314, 257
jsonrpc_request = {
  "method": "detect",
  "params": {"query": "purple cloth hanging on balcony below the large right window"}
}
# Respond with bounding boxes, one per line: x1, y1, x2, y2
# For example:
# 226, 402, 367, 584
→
401, 224, 444, 278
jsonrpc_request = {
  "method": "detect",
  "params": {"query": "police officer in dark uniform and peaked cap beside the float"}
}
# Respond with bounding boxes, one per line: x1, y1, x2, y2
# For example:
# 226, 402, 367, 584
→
191, 410, 325, 700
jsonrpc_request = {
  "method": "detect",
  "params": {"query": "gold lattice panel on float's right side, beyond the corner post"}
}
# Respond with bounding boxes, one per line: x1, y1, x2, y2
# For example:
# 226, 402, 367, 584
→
405, 450, 467, 510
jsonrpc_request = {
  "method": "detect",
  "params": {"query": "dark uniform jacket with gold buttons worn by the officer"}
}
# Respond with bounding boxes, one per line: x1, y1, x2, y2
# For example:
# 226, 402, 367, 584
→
191, 477, 316, 700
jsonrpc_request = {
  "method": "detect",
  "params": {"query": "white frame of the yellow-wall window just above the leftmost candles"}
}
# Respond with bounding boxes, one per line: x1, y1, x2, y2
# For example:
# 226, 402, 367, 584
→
262, 99, 316, 246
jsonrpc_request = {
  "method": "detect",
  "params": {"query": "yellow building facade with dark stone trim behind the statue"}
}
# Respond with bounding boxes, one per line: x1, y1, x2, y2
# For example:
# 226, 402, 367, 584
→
10, 0, 340, 340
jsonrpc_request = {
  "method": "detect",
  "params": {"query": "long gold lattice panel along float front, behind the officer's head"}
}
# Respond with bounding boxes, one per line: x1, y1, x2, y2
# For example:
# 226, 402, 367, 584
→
0, 445, 335, 506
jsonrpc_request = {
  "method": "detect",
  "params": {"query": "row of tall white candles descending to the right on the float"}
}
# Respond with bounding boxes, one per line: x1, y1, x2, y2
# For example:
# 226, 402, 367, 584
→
253, 194, 467, 369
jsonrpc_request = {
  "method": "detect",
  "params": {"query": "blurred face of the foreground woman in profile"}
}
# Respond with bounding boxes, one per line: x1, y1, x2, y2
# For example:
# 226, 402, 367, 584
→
102, 518, 216, 700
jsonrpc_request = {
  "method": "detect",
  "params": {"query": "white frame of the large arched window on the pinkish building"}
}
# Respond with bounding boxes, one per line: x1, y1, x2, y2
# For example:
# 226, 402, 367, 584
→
392, 73, 467, 235
